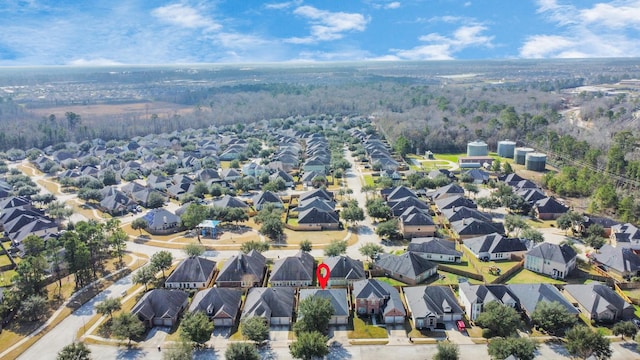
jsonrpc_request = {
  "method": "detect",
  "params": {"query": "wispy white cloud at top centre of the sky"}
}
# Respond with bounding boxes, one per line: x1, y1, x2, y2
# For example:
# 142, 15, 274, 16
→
286, 5, 369, 44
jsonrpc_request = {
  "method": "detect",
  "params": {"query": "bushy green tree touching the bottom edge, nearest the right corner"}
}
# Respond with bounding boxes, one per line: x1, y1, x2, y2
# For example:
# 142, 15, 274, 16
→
565, 325, 612, 360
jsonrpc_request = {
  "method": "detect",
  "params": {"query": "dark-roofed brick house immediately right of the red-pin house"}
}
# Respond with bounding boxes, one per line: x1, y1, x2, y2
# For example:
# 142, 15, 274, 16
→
352, 279, 407, 324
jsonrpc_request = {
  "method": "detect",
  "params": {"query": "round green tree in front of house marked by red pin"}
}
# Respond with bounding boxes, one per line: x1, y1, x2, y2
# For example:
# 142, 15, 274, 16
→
293, 296, 335, 335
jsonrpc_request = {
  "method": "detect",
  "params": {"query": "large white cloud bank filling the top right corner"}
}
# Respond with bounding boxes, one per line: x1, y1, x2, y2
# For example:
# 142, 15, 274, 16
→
520, 0, 640, 58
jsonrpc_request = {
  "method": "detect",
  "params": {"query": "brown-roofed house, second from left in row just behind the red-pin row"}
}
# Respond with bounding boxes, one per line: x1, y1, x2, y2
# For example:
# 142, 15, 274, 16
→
216, 250, 267, 288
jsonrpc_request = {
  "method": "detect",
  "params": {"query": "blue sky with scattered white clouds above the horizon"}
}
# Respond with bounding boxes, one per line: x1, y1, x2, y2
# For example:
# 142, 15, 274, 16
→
0, 0, 640, 66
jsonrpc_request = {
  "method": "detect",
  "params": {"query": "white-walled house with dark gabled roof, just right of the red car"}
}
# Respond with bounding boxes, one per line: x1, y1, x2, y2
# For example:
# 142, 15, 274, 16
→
458, 282, 519, 321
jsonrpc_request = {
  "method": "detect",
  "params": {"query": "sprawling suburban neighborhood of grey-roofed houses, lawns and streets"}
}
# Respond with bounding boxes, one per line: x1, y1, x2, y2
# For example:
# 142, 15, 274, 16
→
0, 117, 640, 358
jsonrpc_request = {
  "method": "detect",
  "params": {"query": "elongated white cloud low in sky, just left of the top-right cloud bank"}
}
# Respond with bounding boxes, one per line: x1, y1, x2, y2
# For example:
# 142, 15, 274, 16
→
392, 25, 493, 60
